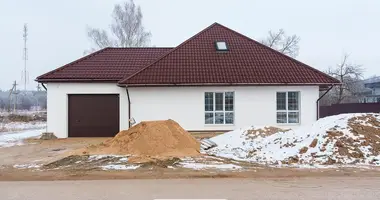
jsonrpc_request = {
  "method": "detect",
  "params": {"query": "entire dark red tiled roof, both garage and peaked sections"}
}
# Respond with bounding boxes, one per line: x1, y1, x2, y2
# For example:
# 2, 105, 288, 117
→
37, 23, 339, 85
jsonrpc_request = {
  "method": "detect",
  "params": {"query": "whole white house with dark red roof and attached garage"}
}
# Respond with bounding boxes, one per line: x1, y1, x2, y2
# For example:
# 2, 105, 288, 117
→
37, 23, 339, 138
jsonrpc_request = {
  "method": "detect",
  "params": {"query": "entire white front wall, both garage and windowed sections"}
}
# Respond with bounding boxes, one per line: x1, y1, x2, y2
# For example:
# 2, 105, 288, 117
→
47, 83, 319, 138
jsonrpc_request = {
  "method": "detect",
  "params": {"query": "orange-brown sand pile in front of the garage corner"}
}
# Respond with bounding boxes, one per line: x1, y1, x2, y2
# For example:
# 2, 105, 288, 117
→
79, 120, 200, 157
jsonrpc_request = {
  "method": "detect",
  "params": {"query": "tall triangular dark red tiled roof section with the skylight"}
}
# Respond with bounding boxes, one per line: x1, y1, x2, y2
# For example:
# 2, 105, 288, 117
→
119, 23, 339, 86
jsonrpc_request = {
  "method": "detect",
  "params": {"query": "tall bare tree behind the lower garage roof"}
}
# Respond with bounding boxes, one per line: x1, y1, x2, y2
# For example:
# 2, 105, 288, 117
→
87, 0, 151, 52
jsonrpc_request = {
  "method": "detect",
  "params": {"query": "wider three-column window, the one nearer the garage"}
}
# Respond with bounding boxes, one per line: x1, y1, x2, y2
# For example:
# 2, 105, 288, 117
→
205, 92, 234, 124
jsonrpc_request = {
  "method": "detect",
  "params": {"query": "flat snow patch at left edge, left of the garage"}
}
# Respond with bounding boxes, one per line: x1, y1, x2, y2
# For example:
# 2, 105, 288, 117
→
0, 129, 44, 148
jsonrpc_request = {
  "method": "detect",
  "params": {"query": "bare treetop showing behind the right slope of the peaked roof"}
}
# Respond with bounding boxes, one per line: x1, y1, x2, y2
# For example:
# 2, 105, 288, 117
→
261, 29, 301, 58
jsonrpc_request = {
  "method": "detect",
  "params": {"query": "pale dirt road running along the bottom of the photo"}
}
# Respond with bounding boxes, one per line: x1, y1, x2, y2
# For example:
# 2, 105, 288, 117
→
0, 177, 380, 200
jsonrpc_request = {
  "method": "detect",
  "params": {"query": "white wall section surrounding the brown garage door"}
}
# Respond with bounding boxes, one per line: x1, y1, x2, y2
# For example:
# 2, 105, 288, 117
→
47, 83, 128, 138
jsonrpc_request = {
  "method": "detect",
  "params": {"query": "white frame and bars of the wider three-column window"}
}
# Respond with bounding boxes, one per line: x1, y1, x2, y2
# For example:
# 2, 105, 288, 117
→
203, 91, 235, 126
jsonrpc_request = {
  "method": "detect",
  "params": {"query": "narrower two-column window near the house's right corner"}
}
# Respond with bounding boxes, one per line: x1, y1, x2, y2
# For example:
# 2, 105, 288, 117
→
276, 92, 300, 124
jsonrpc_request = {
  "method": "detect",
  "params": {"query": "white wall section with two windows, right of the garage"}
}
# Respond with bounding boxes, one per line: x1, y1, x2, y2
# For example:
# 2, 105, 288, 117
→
129, 86, 319, 131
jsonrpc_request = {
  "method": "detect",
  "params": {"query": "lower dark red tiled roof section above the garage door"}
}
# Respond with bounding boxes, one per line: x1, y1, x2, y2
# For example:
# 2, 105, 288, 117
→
37, 48, 172, 82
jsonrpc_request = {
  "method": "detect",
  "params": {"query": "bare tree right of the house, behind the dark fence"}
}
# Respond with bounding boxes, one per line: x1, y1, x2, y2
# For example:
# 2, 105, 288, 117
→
328, 54, 364, 104
